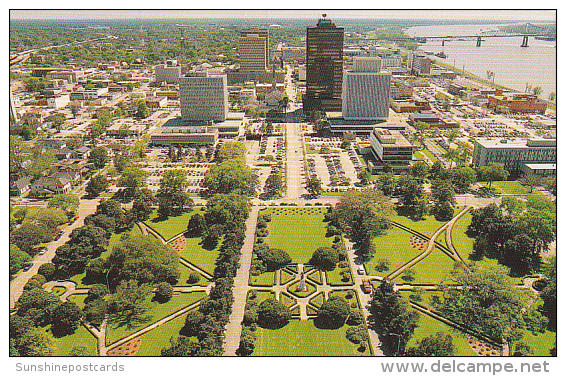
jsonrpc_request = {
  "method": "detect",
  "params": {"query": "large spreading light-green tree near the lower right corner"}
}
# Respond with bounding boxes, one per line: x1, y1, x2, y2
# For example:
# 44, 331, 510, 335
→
433, 265, 547, 345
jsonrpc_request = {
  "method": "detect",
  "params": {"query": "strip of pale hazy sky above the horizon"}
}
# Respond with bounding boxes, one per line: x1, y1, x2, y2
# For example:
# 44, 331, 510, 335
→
10, 9, 556, 21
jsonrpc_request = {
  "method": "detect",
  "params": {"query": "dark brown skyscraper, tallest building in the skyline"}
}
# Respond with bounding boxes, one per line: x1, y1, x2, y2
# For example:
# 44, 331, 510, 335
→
303, 14, 344, 112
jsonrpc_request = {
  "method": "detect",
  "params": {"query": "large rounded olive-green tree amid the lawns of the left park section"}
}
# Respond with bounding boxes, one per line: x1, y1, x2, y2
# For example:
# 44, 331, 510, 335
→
108, 235, 180, 285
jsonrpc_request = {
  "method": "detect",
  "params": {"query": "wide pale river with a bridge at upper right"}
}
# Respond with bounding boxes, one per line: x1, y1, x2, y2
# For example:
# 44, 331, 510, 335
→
406, 25, 556, 99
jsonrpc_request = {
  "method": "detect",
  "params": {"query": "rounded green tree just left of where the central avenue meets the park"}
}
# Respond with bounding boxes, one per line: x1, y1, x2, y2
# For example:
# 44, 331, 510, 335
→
203, 160, 258, 196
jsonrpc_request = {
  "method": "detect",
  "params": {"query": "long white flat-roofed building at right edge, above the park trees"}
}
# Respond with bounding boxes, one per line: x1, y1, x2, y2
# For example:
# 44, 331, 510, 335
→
473, 138, 556, 172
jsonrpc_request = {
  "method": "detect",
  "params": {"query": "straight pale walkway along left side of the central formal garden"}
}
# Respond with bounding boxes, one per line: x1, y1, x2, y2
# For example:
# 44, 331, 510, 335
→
224, 206, 259, 356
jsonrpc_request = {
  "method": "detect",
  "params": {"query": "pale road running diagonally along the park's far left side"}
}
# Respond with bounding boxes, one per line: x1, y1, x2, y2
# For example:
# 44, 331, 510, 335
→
10, 199, 100, 308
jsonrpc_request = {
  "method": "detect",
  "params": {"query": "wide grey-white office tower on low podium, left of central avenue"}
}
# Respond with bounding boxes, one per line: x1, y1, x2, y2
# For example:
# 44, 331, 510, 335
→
179, 75, 228, 122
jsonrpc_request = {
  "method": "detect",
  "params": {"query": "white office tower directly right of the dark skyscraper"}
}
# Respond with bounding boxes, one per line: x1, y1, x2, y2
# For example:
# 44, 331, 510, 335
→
342, 57, 391, 120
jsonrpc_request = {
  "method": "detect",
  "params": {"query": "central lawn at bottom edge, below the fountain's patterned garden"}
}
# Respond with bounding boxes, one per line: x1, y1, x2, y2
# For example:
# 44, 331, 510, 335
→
252, 320, 370, 356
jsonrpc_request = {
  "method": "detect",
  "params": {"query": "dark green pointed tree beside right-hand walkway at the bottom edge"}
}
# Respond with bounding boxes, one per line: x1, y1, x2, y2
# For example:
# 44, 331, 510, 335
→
370, 279, 419, 355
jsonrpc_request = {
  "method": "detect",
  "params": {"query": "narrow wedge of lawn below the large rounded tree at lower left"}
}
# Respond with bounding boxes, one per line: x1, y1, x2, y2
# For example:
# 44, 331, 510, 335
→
106, 292, 206, 344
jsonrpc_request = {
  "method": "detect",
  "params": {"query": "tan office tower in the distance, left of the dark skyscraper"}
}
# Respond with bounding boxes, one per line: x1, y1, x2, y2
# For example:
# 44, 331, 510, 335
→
240, 29, 269, 72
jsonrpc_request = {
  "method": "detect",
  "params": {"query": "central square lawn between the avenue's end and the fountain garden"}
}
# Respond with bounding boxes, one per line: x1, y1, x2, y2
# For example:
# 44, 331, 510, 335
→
261, 207, 333, 264
